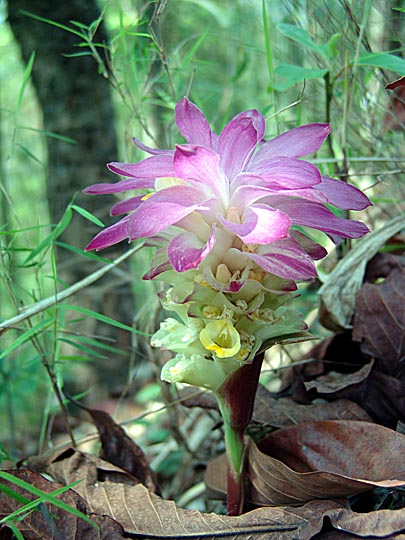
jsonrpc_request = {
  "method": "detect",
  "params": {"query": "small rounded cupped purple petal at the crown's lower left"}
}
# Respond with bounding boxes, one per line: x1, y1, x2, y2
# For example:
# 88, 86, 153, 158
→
167, 227, 215, 272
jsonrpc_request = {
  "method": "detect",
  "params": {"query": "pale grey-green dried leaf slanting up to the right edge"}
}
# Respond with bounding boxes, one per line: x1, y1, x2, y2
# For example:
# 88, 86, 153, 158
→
319, 214, 405, 331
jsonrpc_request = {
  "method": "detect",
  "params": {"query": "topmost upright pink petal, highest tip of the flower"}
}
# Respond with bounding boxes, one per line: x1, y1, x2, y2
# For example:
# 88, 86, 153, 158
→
175, 97, 212, 148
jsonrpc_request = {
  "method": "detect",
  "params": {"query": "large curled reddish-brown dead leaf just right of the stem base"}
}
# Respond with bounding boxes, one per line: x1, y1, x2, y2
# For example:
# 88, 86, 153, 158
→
206, 420, 405, 506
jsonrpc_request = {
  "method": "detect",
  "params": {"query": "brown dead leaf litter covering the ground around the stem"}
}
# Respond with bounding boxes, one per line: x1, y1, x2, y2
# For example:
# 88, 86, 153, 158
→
0, 254, 405, 540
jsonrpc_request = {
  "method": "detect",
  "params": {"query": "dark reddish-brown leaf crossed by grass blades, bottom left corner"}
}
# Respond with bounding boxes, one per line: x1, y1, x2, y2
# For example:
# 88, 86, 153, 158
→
0, 469, 124, 540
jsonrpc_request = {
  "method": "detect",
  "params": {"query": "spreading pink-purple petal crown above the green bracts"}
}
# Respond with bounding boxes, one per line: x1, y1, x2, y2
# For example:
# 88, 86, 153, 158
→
85, 98, 370, 288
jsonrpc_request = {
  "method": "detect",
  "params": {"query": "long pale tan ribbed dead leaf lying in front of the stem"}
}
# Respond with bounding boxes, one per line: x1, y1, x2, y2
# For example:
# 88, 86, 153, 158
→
30, 450, 306, 540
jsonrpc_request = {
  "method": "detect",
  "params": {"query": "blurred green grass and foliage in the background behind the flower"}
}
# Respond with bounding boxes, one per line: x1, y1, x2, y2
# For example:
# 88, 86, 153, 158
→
0, 0, 405, 476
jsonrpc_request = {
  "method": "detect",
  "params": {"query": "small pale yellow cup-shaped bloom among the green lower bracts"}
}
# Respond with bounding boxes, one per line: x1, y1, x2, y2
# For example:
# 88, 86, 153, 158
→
199, 319, 240, 358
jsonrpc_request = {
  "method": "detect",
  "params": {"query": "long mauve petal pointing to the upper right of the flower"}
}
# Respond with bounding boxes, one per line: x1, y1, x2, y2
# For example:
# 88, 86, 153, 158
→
253, 124, 330, 164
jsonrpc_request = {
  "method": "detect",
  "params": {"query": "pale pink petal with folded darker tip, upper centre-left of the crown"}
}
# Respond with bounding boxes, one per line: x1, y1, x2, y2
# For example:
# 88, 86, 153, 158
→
174, 144, 229, 203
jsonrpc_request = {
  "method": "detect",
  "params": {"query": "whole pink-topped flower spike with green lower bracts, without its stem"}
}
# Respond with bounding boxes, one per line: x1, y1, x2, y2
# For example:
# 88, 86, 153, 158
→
85, 98, 370, 389
